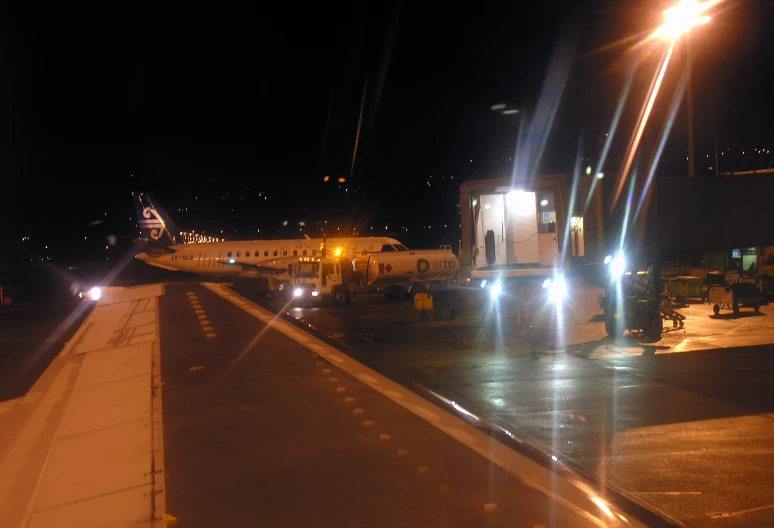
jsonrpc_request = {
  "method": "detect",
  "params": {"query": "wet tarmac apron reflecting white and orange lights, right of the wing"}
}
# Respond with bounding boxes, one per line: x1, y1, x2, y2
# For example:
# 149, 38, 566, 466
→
260, 291, 774, 526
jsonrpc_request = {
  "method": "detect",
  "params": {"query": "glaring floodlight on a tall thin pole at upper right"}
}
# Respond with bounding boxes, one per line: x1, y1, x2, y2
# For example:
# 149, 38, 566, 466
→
655, 0, 717, 178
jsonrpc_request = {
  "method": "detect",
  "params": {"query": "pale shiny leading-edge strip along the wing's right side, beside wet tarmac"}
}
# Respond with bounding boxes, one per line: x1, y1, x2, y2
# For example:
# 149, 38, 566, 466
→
200, 283, 643, 527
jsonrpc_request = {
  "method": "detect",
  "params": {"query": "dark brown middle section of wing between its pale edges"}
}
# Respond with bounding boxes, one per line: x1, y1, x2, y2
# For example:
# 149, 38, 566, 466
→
159, 284, 618, 527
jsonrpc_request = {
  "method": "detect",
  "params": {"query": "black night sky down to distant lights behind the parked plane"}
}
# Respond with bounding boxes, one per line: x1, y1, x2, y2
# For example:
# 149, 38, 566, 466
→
0, 0, 774, 259
